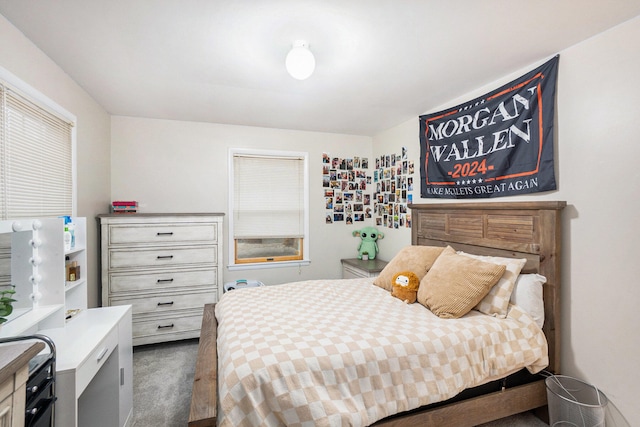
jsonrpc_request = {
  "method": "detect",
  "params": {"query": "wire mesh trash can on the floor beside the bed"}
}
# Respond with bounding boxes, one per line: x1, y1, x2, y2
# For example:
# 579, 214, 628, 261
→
545, 375, 609, 427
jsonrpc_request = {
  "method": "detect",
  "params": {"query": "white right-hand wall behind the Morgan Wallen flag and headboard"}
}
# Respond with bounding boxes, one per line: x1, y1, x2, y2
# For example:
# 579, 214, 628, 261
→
373, 17, 640, 426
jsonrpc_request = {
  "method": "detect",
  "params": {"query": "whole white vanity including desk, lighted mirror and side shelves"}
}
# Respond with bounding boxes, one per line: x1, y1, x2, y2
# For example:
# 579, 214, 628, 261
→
0, 218, 133, 427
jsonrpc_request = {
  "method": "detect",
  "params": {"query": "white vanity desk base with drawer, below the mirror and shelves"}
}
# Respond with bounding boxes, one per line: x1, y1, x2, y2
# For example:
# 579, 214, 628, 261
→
38, 305, 133, 427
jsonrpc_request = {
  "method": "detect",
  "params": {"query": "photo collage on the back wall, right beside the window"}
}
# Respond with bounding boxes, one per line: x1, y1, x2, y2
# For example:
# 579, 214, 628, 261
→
322, 153, 373, 224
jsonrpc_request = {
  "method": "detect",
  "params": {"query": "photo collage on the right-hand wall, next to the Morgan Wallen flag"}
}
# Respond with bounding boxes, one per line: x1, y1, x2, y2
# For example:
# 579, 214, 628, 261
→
372, 147, 415, 228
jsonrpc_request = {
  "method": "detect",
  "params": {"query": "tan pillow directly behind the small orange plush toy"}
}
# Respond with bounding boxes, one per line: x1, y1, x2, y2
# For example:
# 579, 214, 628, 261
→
373, 246, 444, 291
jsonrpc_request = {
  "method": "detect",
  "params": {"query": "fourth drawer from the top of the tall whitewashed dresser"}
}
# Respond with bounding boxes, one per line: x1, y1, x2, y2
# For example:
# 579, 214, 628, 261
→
109, 289, 217, 315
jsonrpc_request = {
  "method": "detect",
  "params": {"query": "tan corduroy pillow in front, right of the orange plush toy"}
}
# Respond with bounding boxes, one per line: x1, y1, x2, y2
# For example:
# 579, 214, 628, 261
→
418, 246, 506, 319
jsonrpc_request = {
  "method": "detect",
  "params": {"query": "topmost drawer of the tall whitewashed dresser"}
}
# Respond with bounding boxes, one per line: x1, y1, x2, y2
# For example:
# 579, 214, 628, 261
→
109, 224, 218, 245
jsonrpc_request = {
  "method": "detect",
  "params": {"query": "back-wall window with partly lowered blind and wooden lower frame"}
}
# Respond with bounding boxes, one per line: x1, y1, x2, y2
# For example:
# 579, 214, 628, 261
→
229, 149, 309, 267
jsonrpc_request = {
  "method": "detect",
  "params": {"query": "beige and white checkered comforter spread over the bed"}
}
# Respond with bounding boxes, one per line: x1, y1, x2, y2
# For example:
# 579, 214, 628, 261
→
216, 279, 548, 427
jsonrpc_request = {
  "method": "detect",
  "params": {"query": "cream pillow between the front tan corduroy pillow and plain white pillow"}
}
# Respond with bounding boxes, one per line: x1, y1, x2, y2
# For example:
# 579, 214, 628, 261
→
458, 252, 527, 318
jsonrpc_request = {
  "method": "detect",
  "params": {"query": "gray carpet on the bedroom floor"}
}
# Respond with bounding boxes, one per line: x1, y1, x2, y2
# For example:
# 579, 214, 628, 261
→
133, 340, 547, 427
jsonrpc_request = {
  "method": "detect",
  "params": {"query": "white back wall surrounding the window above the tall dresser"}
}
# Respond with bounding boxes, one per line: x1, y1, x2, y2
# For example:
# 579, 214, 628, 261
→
111, 116, 372, 284
